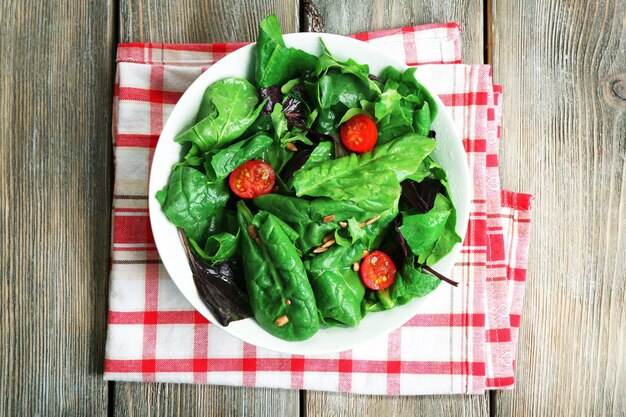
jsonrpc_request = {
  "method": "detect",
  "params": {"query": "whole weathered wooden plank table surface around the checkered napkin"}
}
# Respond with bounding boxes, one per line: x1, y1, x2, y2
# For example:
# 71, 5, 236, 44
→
0, 0, 626, 417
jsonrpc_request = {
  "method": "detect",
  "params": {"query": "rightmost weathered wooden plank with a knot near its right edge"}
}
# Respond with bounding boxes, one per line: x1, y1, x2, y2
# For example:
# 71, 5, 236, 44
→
493, 0, 626, 417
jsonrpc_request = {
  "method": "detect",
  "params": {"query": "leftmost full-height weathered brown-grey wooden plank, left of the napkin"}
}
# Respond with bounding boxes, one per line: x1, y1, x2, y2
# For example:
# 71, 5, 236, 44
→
0, 0, 114, 416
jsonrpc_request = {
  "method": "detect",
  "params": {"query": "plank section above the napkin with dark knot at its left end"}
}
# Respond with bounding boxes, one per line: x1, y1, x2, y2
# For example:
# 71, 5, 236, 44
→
302, 0, 484, 64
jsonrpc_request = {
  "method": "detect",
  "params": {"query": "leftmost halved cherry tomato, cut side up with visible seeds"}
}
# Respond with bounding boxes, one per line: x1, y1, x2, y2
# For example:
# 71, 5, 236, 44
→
228, 160, 276, 198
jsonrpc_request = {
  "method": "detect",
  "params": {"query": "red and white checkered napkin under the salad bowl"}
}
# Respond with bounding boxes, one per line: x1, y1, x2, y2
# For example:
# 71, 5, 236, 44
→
105, 23, 532, 395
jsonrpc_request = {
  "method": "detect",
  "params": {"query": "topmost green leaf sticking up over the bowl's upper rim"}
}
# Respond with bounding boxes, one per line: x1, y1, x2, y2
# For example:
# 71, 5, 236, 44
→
255, 15, 318, 87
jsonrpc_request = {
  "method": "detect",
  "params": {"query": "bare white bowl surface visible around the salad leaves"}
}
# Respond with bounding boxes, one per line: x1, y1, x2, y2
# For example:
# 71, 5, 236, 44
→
149, 33, 471, 354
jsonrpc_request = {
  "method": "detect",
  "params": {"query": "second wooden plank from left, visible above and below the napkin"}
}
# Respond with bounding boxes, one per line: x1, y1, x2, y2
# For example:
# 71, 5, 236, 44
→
114, 0, 300, 417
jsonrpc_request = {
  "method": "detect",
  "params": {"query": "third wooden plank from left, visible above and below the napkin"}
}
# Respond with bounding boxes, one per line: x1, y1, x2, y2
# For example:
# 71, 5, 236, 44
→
302, 0, 489, 416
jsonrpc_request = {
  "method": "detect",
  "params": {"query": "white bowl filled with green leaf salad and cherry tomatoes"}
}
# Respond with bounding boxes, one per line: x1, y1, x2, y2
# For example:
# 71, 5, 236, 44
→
149, 16, 471, 354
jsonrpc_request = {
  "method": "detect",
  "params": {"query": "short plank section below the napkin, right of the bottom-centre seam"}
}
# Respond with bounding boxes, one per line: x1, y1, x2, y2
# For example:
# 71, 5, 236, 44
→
304, 392, 489, 417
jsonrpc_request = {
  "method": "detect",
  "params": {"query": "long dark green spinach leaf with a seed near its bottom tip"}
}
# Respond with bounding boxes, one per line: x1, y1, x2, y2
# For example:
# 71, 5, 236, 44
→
237, 201, 320, 341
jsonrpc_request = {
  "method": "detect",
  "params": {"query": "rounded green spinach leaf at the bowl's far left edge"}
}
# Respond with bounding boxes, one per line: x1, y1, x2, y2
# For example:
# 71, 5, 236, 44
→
157, 165, 229, 242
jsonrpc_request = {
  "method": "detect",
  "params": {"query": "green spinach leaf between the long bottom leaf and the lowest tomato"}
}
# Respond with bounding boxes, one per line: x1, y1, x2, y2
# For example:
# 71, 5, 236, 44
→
305, 243, 365, 326
